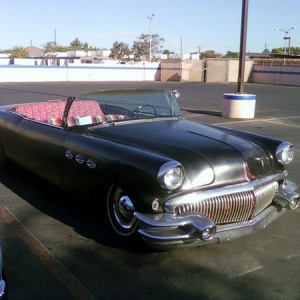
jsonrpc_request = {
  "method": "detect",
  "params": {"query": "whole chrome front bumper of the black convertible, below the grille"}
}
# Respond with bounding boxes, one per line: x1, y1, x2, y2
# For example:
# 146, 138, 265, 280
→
135, 176, 299, 250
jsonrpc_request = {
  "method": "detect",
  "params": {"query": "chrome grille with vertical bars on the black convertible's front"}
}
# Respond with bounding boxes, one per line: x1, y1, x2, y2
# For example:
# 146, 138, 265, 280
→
174, 182, 278, 224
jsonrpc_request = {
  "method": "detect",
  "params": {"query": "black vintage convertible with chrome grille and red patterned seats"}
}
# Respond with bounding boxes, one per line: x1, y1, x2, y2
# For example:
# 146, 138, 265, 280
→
0, 89, 299, 250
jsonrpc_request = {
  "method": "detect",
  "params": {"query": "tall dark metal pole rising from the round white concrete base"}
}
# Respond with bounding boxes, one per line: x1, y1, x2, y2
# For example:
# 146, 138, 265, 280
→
237, 0, 248, 94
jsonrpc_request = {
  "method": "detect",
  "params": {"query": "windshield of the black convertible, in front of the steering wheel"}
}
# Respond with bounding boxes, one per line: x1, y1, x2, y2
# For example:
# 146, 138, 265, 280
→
68, 89, 181, 126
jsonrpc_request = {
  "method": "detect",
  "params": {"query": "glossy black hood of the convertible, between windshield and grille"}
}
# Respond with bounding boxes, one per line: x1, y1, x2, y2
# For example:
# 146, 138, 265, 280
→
90, 119, 272, 186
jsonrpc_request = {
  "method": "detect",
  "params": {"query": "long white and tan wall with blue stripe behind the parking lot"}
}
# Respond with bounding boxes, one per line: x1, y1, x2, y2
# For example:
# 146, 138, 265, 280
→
0, 58, 300, 86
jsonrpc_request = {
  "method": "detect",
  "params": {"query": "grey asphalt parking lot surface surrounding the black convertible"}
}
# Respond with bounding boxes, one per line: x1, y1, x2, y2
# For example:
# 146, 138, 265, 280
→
0, 82, 300, 300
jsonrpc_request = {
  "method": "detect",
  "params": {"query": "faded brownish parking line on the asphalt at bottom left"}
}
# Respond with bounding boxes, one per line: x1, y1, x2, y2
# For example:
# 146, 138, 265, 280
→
0, 204, 96, 300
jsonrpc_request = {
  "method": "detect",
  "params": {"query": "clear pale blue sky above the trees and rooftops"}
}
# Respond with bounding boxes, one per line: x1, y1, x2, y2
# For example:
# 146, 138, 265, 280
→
0, 0, 300, 54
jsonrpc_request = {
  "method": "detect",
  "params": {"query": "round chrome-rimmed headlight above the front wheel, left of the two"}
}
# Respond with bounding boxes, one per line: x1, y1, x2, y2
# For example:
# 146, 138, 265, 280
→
157, 161, 185, 191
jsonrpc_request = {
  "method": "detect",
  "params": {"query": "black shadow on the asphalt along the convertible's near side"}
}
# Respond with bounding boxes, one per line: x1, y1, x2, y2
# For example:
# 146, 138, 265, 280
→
0, 168, 154, 253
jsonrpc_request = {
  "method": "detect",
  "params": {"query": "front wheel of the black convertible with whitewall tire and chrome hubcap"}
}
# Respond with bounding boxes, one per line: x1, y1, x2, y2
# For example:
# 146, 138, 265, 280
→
106, 185, 137, 238
